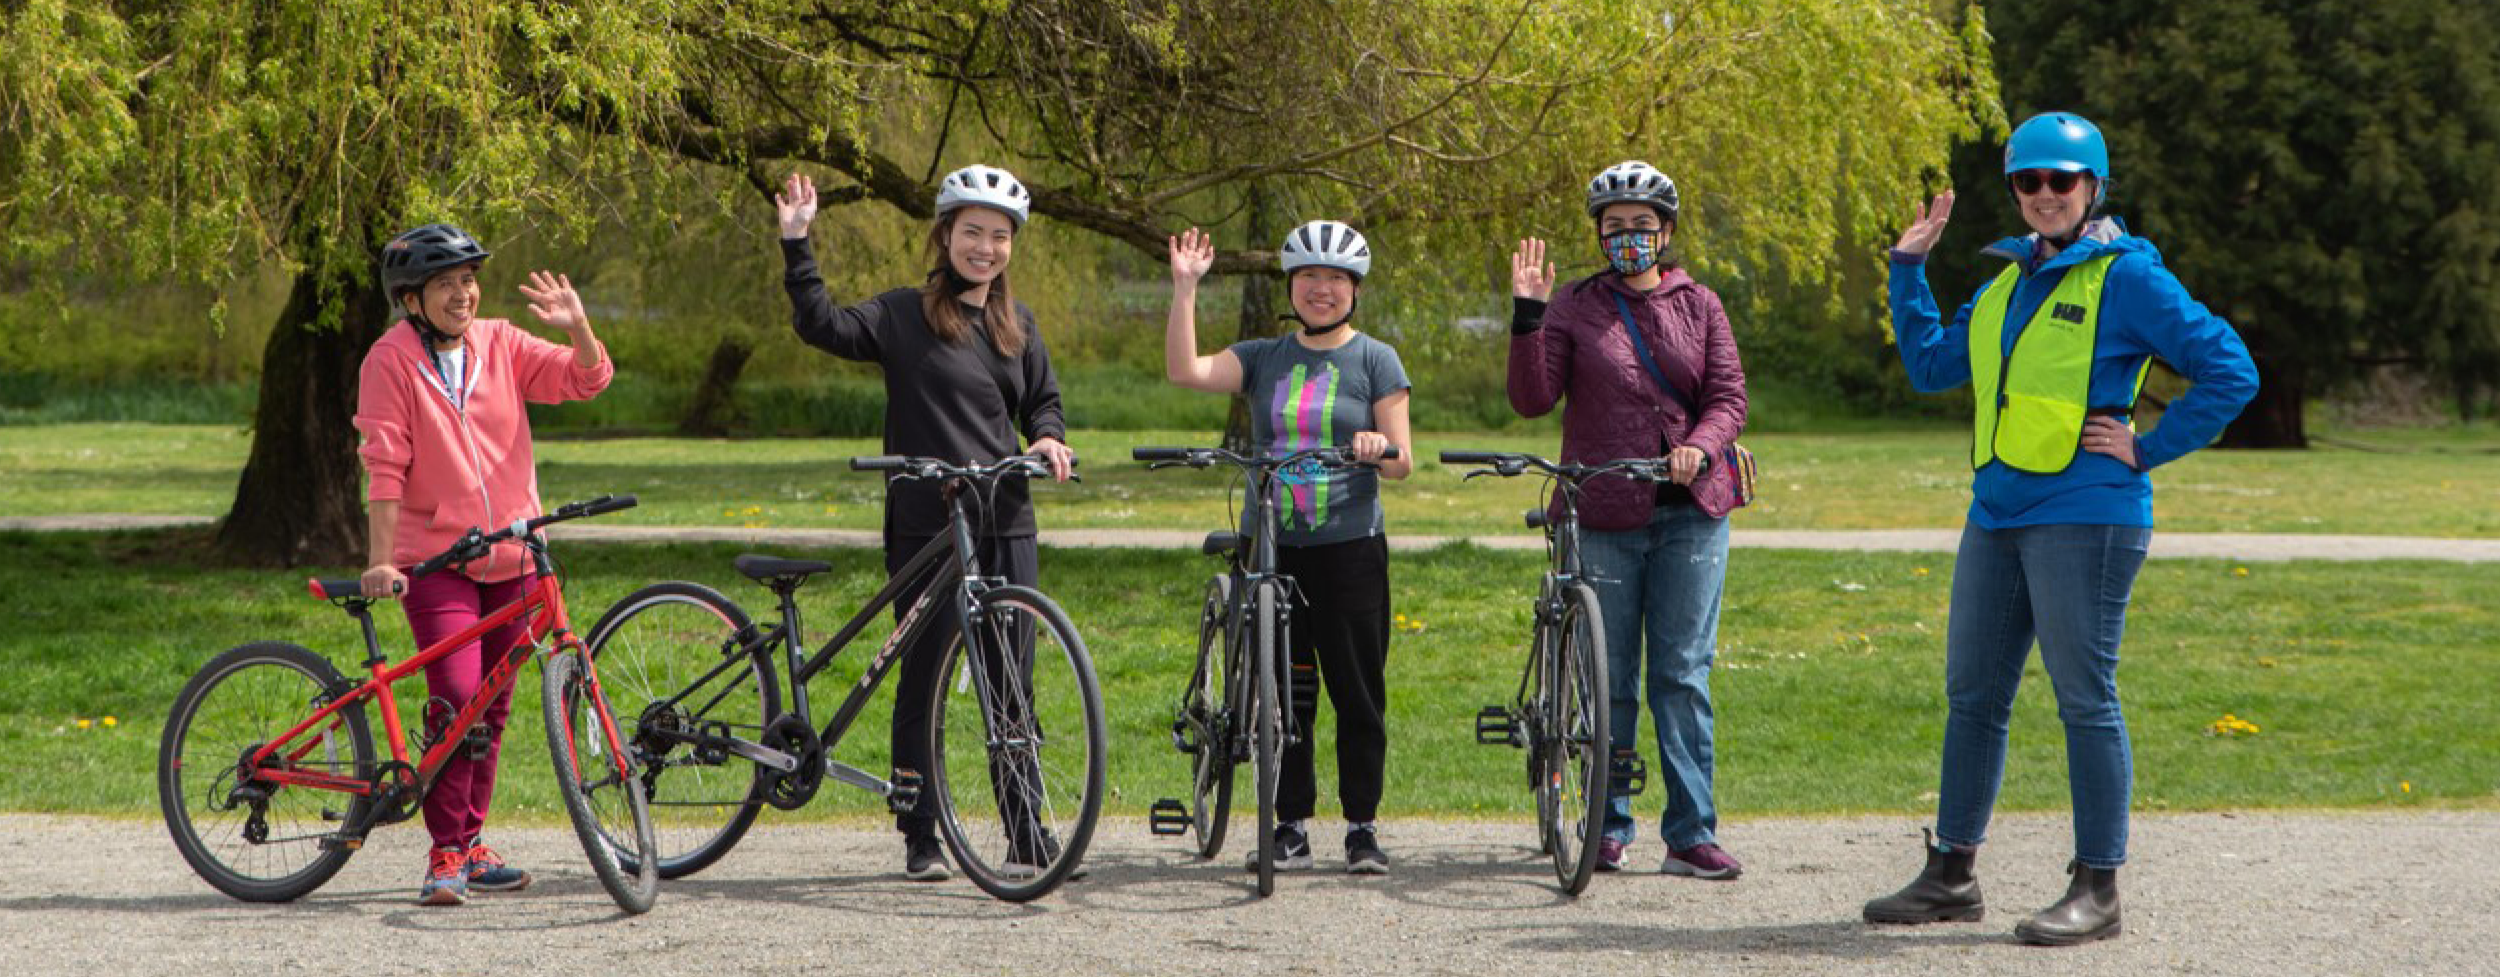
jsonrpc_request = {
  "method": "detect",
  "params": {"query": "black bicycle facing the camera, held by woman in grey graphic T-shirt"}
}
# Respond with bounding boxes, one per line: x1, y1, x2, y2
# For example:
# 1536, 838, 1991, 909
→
1133, 447, 1398, 895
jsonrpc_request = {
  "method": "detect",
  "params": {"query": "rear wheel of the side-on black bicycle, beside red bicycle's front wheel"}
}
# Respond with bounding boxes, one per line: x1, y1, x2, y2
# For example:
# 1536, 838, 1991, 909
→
588, 582, 780, 880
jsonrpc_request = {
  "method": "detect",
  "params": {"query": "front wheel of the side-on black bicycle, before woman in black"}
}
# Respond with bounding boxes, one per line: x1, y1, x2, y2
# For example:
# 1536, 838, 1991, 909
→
930, 587, 1108, 902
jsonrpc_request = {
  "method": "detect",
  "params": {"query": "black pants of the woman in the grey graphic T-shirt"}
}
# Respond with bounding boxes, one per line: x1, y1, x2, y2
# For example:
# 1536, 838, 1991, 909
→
1275, 537, 1390, 825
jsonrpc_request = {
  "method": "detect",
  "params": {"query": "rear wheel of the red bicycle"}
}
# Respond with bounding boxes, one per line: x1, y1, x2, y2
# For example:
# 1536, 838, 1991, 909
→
158, 642, 375, 902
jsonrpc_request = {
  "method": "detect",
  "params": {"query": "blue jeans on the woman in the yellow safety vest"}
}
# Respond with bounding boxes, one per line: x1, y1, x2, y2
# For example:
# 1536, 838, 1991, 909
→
1935, 525, 2153, 870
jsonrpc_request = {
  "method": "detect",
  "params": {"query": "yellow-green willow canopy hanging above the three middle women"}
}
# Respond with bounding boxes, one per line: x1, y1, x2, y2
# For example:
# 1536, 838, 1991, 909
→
583, 0, 2003, 439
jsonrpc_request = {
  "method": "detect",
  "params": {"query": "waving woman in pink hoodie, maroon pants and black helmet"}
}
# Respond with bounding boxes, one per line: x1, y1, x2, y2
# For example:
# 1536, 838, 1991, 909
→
355, 225, 615, 905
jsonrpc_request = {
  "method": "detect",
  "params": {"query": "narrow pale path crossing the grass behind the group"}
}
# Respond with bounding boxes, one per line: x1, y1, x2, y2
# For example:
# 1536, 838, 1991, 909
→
14, 512, 2500, 562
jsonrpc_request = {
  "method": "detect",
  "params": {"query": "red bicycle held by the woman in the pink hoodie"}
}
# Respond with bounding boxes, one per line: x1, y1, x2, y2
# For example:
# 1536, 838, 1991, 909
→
158, 495, 660, 912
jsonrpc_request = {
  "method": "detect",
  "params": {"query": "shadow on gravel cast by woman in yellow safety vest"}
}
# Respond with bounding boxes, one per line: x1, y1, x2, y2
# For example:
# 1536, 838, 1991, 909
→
1485, 922, 2013, 960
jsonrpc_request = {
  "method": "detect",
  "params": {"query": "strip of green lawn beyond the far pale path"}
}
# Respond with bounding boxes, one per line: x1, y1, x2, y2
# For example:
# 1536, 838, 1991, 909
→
0, 425, 2500, 537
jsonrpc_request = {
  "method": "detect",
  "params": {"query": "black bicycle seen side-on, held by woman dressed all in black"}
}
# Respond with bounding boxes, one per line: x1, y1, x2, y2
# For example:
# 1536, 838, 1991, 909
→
590, 455, 1105, 902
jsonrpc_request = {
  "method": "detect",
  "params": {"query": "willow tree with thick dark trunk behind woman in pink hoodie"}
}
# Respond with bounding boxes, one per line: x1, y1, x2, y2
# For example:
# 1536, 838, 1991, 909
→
0, 0, 673, 565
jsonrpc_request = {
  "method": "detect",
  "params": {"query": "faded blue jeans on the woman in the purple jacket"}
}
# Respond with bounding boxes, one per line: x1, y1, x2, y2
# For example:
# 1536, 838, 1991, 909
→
1580, 505, 1728, 850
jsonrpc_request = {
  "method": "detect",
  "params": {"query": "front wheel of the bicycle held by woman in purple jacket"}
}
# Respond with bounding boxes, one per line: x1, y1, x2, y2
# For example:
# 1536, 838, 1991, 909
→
1535, 585, 1613, 895
